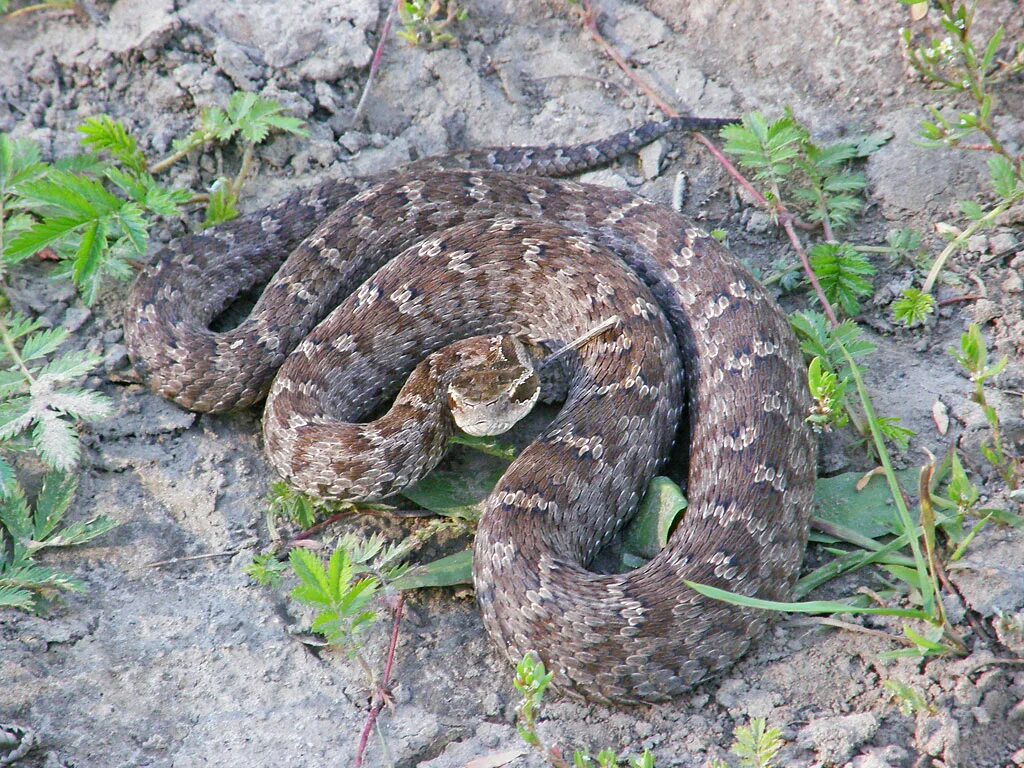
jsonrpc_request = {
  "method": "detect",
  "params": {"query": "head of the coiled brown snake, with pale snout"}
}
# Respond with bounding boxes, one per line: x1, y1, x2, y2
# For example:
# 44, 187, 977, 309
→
447, 335, 541, 437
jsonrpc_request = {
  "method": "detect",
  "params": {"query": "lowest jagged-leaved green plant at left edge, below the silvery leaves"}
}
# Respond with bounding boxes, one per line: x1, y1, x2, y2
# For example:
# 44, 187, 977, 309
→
0, 471, 117, 610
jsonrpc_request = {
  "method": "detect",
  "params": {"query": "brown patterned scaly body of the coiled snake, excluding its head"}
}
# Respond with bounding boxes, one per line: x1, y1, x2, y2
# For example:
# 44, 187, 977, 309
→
125, 119, 815, 705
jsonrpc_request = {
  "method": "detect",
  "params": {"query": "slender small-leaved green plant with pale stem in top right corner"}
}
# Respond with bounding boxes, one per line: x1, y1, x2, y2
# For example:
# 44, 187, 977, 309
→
893, 0, 1024, 327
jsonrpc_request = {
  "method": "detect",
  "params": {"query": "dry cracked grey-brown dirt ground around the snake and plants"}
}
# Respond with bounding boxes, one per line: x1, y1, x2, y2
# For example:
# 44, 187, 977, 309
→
0, 0, 1024, 768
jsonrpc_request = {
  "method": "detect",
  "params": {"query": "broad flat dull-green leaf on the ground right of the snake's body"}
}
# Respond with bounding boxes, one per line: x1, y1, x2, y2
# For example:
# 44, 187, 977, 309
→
814, 467, 919, 539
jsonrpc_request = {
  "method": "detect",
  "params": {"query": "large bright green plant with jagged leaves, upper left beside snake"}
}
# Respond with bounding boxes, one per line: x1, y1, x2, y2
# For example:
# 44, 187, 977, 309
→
0, 92, 303, 303
